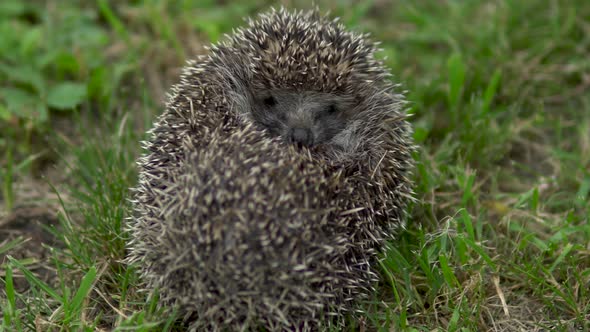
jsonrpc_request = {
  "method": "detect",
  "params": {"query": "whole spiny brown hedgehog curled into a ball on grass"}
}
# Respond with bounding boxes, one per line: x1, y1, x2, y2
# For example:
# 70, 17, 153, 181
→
126, 8, 415, 331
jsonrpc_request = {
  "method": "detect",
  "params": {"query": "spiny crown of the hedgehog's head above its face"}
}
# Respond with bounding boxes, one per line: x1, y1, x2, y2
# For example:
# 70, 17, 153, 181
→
211, 9, 389, 95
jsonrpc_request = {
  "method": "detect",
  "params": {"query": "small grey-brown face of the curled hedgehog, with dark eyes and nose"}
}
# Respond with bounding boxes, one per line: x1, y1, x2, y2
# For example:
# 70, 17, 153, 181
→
251, 90, 353, 147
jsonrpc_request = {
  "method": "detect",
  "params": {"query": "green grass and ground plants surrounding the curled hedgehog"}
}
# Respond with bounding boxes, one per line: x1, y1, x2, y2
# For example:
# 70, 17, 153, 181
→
0, 0, 590, 331
